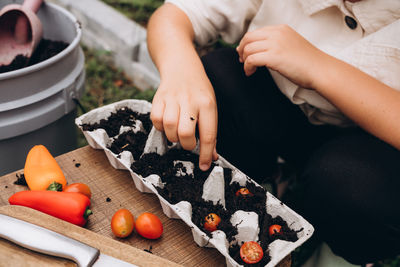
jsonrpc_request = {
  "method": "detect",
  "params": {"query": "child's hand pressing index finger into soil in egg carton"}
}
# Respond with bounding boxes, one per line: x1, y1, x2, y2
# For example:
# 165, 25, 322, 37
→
150, 71, 218, 171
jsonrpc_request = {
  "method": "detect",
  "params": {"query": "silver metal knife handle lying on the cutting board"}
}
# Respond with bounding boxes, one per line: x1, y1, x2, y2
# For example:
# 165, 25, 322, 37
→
0, 214, 100, 267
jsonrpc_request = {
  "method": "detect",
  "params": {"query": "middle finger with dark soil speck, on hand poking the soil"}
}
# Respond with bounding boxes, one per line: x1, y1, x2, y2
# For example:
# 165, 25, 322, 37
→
178, 106, 198, 150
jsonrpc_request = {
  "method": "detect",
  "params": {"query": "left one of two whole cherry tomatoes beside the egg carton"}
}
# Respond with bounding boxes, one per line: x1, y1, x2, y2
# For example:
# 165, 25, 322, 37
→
111, 209, 135, 237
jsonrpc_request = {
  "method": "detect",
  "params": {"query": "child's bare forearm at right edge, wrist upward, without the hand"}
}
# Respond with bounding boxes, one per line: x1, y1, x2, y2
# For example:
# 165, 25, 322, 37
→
312, 55, 400, 150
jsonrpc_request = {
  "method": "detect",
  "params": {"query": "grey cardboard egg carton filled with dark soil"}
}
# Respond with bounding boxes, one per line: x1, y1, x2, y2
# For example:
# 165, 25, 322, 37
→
75, 99, 314, 267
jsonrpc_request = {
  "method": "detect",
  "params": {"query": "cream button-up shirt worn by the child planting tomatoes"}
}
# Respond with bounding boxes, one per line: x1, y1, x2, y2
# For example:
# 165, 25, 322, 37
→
166, 0, 400, 126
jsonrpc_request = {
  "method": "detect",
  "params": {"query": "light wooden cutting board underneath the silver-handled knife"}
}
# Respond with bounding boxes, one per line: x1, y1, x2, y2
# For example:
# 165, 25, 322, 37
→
0, 206, 181, 267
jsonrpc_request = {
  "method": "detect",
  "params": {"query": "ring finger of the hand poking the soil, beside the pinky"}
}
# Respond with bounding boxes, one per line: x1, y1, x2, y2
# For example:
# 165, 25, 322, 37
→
163, 101, 180, 142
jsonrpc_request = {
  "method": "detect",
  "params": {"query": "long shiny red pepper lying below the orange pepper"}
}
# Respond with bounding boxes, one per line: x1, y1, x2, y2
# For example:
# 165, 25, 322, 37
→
8, 191, 92, 226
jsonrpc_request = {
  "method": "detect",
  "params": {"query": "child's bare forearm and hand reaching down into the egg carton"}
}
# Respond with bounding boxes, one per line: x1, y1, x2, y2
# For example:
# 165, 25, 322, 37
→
147, 3, 218, 171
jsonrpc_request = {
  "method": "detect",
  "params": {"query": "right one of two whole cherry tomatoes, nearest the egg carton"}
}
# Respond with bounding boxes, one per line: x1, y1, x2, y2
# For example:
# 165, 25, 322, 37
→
136, 212, 163, 239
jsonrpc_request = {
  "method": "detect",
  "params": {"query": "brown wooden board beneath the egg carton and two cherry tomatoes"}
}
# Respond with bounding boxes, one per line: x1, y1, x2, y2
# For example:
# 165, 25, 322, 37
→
0, 146, 225, 266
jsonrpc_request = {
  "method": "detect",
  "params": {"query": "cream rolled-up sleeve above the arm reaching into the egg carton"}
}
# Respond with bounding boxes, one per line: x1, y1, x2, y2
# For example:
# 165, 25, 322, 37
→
165, 0, 262, 46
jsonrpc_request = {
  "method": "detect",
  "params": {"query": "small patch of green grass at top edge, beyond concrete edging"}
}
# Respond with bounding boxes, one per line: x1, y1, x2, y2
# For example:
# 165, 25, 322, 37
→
102, 0, 164, 26
